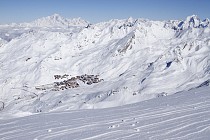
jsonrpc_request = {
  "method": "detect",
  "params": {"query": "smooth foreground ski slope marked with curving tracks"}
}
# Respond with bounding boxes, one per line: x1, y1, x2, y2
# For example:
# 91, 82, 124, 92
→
0, 87, 210, 140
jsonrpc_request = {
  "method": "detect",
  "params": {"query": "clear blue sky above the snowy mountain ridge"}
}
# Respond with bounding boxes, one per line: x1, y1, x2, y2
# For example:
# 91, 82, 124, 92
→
0, 0, 210, 23
